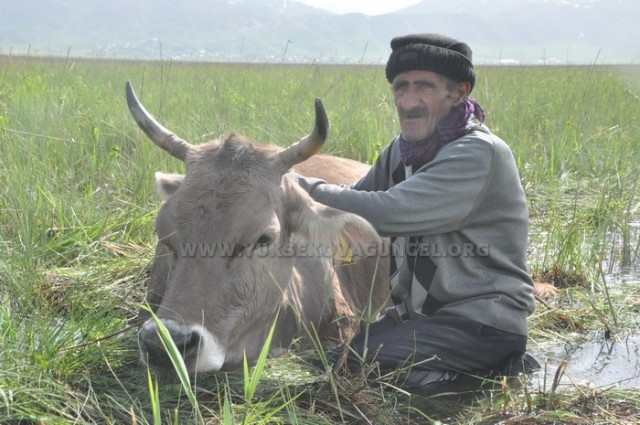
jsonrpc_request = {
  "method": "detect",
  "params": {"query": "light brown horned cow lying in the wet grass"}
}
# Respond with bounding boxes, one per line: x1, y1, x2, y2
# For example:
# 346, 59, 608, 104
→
125, 81, 389, 372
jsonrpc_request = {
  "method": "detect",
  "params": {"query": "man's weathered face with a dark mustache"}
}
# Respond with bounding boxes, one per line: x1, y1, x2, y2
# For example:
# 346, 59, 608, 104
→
391, 71, 468, 142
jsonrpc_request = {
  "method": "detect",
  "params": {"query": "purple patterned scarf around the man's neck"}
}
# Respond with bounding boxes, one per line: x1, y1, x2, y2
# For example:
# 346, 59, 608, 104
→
399, 99, 485, 170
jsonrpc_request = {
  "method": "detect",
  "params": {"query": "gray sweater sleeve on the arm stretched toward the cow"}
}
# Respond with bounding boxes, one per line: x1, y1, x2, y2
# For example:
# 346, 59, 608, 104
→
307, 138, 494, 236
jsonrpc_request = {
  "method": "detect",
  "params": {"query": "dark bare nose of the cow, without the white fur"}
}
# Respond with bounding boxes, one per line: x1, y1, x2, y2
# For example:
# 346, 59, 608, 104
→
138, 320, 201, 369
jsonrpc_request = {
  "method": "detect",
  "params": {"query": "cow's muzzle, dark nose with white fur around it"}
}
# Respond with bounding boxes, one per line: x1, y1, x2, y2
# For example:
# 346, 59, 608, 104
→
138, 319, 225, 372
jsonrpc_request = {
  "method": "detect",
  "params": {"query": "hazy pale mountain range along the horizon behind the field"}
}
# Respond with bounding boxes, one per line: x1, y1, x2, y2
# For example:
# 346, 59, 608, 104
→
0, 0, 640, 63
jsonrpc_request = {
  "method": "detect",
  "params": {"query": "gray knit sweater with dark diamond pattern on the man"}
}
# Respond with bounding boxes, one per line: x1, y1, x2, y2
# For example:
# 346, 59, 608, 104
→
300, 127, 534, 335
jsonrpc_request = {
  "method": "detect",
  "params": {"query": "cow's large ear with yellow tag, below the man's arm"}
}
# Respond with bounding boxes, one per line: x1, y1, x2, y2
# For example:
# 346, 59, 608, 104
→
283, 175, 382, 261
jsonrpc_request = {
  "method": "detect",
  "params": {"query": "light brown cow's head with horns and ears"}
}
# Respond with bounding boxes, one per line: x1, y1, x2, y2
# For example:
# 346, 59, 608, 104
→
126, 82, 377, 371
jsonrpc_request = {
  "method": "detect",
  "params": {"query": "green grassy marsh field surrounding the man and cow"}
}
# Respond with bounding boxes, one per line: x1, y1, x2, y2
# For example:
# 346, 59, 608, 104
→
0, 56, 640, 424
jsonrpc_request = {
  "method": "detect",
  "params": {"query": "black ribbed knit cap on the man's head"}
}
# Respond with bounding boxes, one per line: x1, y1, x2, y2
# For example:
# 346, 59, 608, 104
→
386, 34, 476, 90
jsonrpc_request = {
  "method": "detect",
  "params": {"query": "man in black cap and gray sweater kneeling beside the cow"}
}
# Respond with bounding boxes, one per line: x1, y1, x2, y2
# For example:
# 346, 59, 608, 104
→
297, 34, 534, 390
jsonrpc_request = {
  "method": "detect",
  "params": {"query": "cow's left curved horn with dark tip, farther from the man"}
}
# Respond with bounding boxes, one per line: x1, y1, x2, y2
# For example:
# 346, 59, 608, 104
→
125, 81, 191, 161
